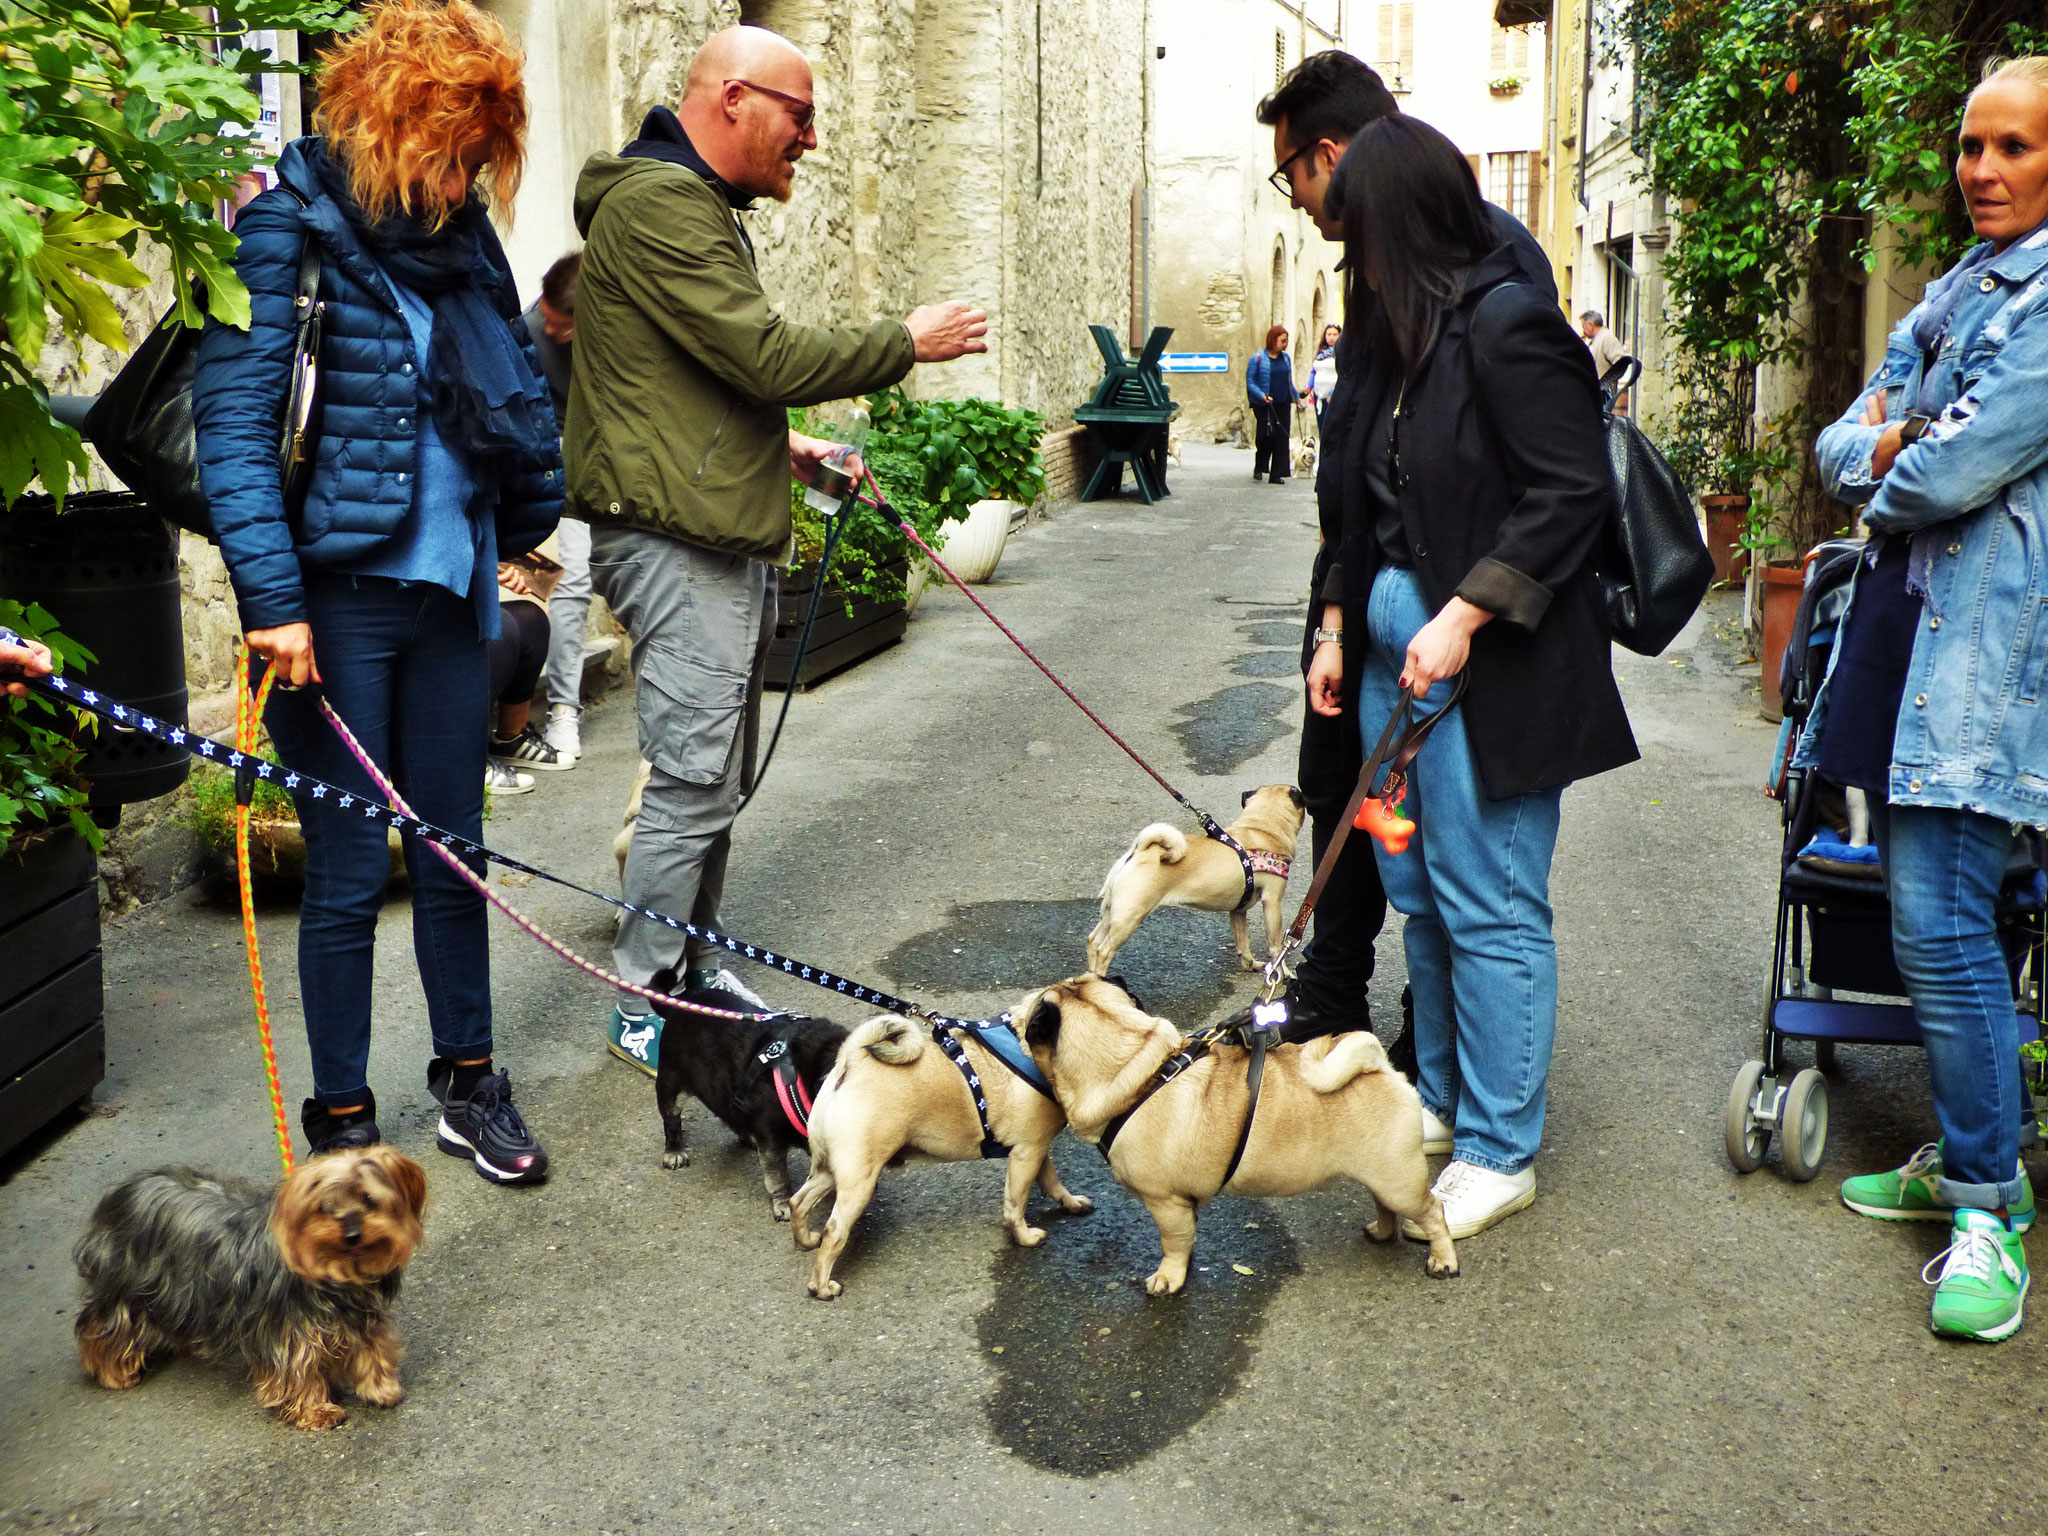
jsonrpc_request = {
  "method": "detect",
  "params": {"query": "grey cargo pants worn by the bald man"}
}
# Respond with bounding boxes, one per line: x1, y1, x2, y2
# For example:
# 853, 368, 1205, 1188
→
590, 528, 778, 985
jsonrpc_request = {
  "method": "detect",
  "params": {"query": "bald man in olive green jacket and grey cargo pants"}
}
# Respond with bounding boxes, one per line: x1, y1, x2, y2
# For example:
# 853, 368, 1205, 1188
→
567, 27, 987, 1073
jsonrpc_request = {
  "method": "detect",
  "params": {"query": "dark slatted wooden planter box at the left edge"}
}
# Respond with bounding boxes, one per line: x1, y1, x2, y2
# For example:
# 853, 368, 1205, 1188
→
0, 829, 106, 1153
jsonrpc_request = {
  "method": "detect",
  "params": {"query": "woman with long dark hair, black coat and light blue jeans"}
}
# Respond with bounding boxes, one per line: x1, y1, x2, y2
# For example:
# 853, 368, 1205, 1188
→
1309, 117, 1636, 1237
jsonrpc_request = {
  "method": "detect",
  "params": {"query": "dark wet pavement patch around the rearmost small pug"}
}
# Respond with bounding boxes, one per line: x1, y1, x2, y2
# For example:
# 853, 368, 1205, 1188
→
881, 901, 1243, 1028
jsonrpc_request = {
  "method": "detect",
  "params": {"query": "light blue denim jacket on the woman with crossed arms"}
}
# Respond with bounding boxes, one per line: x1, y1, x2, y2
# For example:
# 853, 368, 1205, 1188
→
1792, 229, 2048, 827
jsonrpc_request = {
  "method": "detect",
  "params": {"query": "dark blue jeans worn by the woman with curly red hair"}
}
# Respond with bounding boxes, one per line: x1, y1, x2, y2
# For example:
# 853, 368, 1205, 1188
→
266, 571, 492, 1104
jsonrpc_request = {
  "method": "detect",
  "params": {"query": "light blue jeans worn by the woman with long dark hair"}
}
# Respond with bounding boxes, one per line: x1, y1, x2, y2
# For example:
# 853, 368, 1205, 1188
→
1358, 565, 1563, 1174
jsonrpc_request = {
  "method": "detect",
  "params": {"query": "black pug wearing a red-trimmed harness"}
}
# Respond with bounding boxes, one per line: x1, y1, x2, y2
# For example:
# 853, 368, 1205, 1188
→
651, 971, 846, 1221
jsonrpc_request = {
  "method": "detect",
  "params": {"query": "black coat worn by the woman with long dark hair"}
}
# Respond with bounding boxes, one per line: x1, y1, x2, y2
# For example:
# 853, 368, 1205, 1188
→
1337, 246, 1638, 799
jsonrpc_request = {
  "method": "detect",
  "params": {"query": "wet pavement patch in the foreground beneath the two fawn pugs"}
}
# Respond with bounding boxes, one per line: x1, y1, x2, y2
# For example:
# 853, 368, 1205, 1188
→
977, 1187, 1300, 1477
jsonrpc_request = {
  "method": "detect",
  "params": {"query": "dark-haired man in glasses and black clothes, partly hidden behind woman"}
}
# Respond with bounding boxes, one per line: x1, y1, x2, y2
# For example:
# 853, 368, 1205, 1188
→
1220, 49, 1556, 1056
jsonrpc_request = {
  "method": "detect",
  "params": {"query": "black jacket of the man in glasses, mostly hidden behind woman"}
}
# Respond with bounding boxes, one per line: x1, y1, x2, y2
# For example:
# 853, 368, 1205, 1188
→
1296, 203, 1556, 819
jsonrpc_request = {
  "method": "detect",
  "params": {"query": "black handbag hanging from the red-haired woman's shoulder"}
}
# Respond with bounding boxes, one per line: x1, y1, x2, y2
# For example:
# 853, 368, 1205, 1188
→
86, 186, 326, 539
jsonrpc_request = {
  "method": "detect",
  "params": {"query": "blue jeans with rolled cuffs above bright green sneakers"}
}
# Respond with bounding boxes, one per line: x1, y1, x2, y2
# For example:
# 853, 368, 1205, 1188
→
1870, 795, 2030, 1210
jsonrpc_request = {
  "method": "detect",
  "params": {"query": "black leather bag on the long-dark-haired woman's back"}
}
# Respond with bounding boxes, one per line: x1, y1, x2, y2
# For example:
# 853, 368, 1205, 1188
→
1593, 358, 1714, 655
